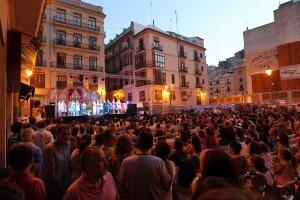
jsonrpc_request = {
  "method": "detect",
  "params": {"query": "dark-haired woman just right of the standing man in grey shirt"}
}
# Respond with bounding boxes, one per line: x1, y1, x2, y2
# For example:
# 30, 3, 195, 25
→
70, 133, 92, 182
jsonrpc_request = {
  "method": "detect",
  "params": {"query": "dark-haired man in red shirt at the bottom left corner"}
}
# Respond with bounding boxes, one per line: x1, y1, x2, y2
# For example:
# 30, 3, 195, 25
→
4, 143, 47, 200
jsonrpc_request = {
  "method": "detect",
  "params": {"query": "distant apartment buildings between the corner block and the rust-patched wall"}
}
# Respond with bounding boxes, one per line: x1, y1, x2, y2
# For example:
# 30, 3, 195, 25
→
208, 50, 246, 104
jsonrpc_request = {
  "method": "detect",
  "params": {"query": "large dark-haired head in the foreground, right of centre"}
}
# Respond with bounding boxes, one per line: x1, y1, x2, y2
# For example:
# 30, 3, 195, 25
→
201, 149, 240, 187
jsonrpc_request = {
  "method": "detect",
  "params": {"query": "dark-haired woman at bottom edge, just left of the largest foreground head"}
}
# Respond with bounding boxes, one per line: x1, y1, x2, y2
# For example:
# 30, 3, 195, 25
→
176, 158, 196, 200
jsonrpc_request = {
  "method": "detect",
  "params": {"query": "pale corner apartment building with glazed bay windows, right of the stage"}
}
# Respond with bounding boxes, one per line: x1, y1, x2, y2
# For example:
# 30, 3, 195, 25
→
105, 22, 209, 113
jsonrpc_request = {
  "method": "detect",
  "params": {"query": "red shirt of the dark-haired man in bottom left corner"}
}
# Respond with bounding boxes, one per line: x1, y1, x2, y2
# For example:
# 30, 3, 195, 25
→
8, 173, 47, 200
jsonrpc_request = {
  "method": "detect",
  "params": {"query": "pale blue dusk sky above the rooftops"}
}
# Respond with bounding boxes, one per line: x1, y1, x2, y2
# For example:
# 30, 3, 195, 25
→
83, 0, 288, 65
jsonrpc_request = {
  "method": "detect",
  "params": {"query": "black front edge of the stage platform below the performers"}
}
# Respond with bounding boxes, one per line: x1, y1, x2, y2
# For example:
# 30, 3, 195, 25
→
61, 113, 135, 123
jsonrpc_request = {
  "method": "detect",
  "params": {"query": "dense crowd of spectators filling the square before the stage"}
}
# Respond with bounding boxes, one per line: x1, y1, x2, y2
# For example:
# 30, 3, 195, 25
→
0, 104, 300, 200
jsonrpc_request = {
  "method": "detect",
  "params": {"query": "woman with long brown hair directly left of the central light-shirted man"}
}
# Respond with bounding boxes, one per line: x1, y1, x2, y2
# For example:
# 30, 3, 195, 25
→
108, 134, 134, 180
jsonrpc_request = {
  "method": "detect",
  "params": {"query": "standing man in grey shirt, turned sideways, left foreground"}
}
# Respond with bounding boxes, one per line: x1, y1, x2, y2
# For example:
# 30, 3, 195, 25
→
42, 124, 72, 200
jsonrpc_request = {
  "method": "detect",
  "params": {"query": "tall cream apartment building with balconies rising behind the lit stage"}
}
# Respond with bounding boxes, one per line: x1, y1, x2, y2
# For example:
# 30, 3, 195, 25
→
22, 0, 105, 115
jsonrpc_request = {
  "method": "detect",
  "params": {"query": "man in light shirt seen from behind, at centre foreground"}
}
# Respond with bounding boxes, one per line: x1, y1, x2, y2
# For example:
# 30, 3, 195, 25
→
117, 132, 173, 200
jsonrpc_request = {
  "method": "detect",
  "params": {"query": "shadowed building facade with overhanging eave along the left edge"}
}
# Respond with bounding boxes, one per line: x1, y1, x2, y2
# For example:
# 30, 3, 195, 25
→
0, 0, 47, 168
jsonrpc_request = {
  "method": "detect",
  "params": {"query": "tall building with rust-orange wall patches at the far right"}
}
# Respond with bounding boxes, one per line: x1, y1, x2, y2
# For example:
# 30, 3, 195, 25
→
244, 0, 300, 103
